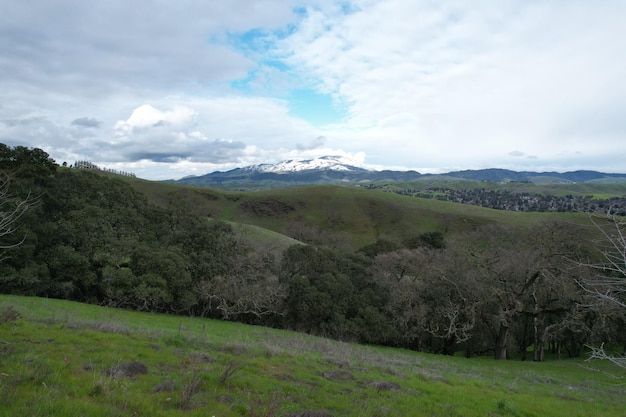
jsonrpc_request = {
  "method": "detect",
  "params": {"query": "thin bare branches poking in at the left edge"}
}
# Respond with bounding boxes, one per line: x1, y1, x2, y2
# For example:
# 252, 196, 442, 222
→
0, 176, 36, 261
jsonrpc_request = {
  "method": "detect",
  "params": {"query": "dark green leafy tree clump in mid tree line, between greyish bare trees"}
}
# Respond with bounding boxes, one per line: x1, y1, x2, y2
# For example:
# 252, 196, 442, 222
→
280, 245, 388, 343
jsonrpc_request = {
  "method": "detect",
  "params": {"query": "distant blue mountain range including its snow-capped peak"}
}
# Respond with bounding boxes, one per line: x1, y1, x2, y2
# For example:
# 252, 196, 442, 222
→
168, 156, 626, 190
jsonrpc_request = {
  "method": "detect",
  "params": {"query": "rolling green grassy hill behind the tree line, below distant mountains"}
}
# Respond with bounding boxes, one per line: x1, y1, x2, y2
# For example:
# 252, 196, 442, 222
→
120, 179, 588, 250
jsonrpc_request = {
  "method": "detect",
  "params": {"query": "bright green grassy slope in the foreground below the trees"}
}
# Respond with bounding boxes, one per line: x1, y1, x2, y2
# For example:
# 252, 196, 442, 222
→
0, 295, 626, 417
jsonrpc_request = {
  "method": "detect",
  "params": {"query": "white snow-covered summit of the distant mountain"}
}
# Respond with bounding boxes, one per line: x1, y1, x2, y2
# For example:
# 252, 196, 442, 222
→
241, 156, 367, 174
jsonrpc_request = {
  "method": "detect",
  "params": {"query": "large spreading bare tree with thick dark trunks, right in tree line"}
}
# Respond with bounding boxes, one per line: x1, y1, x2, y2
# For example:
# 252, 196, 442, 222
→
460, 222, 584, 361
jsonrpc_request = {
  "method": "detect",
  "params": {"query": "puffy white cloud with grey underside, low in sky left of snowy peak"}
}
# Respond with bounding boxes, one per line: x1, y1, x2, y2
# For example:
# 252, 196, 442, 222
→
80, 97, 323, 171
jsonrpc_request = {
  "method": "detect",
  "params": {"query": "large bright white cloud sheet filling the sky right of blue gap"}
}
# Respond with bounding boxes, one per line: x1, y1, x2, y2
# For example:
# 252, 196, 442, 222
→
279, 0, 626, 171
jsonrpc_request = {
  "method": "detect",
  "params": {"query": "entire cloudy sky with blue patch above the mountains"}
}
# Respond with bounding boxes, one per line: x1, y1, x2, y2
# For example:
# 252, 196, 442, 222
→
0, 0, 626, 180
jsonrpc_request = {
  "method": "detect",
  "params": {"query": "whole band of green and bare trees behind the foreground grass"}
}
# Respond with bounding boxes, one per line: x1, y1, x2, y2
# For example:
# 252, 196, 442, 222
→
0, 144, 626, 361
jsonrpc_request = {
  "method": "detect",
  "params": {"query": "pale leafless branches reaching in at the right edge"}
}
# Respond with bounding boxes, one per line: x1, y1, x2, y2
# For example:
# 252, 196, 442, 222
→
580, 212, 626, 368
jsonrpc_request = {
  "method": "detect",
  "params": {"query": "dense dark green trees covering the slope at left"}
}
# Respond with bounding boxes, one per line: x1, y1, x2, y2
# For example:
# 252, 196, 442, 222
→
0, 152, 244, 312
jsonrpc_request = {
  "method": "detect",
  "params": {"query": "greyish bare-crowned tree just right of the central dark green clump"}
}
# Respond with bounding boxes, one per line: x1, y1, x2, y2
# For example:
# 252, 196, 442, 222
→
372, 246, 476, 355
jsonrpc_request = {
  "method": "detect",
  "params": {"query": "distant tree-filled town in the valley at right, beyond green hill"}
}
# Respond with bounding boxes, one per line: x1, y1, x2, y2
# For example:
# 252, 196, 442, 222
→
399, 188, 626, 216
